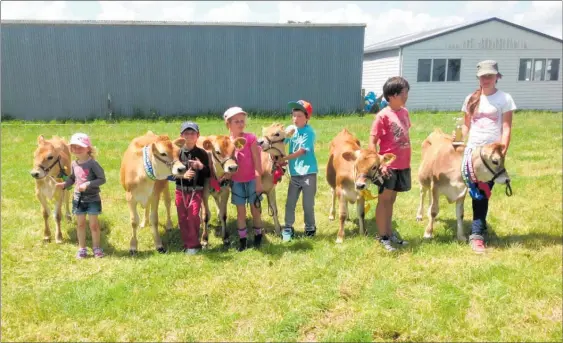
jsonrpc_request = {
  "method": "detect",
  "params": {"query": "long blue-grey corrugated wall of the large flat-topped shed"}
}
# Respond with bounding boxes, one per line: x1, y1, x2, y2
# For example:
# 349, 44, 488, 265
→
1, 22, 364, 119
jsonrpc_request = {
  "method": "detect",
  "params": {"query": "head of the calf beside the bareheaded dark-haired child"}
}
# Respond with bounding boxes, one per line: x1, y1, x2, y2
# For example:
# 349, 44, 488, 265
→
342, 149, 396, 190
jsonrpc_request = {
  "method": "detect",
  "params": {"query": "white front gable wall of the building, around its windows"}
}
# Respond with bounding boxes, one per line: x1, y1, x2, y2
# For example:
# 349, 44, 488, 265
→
403, 21, 563, 112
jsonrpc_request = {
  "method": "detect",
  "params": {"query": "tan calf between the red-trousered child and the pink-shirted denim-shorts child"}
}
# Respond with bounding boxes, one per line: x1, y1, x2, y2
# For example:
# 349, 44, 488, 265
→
197, 136, 246, 247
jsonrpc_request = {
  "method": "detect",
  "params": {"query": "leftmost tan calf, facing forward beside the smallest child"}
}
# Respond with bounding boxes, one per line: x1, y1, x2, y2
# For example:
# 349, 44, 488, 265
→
30, 135, 72, 243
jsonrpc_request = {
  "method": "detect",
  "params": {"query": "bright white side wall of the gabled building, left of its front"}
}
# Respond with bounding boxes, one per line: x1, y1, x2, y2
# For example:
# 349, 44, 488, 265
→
362, 49, 401, 96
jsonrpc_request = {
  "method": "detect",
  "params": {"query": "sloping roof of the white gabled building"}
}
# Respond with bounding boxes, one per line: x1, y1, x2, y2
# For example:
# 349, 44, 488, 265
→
364, 17, 563, 54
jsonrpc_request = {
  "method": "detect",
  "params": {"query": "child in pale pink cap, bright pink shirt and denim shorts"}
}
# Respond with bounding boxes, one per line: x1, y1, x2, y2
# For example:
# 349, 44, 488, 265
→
223, 107, 263, 251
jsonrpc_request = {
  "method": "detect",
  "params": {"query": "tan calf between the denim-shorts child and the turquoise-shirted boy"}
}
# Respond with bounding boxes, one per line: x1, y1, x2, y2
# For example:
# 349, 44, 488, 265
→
258, 123, 295, 235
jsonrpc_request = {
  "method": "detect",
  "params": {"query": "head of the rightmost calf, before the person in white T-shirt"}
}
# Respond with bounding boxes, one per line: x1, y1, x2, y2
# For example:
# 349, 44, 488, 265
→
474, 143, 510, 184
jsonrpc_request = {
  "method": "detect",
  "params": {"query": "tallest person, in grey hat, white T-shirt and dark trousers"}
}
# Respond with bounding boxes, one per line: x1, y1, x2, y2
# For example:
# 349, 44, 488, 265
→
461, 60, 516, 253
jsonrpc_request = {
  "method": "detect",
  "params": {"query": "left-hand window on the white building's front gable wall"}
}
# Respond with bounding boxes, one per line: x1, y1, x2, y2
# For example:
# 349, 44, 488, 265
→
416, 58, 461, 82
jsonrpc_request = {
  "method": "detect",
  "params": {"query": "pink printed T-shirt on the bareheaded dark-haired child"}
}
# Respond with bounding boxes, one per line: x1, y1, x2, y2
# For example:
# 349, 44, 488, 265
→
371, 106, 411, 169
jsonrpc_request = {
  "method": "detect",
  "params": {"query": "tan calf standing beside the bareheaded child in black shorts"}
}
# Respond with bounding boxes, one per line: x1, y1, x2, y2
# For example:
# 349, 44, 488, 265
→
326, 129, 395, 243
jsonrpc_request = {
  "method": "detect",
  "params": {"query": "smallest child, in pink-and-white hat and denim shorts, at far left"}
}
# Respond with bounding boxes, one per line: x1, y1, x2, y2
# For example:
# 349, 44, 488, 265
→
56, 133, 106, 259
